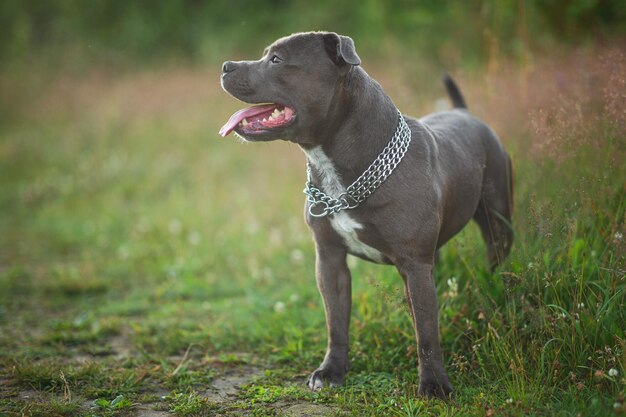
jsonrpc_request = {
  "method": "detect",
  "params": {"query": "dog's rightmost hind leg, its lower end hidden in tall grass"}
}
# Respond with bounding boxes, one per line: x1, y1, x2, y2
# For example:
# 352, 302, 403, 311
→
474, 156, 513, 272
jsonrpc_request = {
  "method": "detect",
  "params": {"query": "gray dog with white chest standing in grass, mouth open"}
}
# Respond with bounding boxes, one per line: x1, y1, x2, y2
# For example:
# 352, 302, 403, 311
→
220, 32, 513, 398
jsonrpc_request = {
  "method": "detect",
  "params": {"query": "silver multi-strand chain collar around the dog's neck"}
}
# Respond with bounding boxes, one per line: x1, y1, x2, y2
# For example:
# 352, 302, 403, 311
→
304, 111, 411, 217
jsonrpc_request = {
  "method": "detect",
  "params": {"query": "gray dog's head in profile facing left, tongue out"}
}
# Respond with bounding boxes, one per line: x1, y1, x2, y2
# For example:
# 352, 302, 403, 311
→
220, 32, 361, 144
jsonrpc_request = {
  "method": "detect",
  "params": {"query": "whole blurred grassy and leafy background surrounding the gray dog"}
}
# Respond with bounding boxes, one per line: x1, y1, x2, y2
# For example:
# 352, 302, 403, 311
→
0, 0, 626, 415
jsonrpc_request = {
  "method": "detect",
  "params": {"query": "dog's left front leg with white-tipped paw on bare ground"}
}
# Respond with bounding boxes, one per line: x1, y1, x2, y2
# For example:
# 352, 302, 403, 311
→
308, 244, 352, 390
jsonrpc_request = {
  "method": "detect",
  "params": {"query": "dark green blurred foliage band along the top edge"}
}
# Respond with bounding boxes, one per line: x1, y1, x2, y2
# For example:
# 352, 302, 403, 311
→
0, 0, 626, 66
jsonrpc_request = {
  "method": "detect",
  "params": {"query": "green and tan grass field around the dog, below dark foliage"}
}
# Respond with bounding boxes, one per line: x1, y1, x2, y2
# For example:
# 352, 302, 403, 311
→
0, 40, 626, 416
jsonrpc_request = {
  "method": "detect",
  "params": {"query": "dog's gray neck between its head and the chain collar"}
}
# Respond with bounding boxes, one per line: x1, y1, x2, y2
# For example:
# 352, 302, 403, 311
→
302, 67, 398, 185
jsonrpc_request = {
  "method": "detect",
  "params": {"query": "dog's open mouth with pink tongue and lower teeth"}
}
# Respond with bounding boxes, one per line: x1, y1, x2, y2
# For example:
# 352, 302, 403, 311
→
220, 103, 296, 137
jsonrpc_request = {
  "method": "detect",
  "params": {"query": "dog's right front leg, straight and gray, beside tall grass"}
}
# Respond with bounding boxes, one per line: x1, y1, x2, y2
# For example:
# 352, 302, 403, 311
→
396, 258, 452, 399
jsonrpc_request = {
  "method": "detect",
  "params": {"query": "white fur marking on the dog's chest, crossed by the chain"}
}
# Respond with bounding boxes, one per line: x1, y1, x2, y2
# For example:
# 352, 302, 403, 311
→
305, 146, 384, 263
